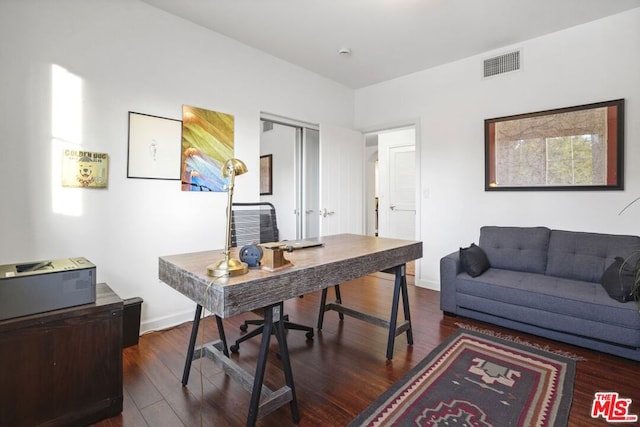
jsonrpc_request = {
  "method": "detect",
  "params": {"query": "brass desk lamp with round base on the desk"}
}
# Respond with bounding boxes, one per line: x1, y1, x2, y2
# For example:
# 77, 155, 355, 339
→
207, 159, 249, 277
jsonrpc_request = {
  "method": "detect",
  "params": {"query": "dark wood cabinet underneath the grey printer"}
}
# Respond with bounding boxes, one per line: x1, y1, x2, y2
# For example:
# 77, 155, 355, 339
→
0, 283, 123, 427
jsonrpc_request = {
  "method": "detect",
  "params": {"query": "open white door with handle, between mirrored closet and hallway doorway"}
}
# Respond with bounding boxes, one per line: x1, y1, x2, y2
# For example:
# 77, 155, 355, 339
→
320, 124, 364, 236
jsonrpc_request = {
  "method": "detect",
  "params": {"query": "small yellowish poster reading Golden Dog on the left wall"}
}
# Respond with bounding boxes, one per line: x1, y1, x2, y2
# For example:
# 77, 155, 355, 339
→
62, 150, 109, 188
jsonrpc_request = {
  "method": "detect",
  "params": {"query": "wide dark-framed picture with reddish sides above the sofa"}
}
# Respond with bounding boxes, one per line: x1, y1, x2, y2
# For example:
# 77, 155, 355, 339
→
484, 99, 624, 191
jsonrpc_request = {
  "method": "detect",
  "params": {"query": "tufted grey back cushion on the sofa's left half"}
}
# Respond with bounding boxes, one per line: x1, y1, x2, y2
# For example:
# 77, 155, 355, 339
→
479, 226, 551, 274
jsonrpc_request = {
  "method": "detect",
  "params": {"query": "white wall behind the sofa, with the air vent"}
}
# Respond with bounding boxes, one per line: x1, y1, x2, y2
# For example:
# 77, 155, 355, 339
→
355, 9, 640, 289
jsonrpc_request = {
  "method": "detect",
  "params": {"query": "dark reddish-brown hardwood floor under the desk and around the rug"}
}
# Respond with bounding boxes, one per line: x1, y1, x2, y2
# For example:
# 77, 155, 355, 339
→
96, 275, 640, 427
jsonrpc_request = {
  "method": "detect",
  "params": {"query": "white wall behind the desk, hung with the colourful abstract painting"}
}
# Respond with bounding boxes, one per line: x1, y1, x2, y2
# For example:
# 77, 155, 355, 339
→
0, 0, 354, 330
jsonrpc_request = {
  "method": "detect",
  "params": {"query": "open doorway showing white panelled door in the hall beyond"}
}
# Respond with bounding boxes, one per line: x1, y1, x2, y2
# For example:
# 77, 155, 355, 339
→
378, 128, 416, 240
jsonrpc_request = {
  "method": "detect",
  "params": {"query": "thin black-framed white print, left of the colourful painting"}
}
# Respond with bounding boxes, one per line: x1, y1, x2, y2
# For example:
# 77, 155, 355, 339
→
127, 111, 182, 180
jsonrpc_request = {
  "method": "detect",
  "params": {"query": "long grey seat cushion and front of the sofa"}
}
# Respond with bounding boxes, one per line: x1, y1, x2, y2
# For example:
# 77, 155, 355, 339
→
456, 267, 640, 347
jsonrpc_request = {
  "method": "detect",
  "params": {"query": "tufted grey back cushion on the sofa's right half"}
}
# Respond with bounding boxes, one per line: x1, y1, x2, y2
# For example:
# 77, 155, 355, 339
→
544, 230, 640, 283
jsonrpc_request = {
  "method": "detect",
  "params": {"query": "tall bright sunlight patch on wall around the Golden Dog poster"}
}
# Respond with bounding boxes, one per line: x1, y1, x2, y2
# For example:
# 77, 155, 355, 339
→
51, 64, 82, 216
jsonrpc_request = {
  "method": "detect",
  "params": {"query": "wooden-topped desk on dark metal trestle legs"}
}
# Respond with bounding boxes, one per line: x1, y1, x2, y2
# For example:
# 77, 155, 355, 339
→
159, 234, 422, 425
